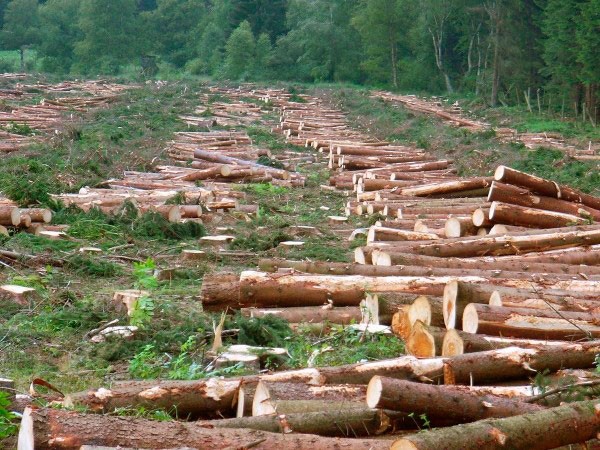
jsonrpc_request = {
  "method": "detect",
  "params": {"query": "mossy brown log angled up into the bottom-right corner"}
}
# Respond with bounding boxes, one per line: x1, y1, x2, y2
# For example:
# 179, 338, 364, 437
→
391, 400, 600, 450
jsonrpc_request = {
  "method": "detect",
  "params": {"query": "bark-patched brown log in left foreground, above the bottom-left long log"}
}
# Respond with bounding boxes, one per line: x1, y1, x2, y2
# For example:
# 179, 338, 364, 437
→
64, 378, 240, 418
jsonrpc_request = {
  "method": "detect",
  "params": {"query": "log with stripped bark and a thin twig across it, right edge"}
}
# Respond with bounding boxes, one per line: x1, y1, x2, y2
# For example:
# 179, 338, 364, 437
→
462, 303, 600, 340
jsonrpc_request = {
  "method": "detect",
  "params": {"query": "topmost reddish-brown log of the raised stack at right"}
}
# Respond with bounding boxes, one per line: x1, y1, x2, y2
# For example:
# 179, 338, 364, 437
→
494, 166, 600, 210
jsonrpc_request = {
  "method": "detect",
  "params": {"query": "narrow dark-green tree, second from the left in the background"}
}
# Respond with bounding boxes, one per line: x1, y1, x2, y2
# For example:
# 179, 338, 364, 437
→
36, 0, 81, 73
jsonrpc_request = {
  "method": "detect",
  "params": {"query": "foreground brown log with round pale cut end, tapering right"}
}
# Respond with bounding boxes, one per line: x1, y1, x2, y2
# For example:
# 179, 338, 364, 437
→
367, 376, 545, 424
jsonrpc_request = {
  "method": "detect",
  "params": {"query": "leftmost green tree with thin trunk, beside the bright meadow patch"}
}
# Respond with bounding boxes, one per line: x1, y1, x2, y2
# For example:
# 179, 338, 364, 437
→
2, 0, 39, 71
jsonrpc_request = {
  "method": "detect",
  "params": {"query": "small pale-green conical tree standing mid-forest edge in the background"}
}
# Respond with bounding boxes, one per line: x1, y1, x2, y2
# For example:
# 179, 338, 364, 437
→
223, 20, 256, 79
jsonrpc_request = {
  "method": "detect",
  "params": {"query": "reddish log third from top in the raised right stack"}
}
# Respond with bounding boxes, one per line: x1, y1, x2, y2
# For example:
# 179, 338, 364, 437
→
490, 202, 588, 228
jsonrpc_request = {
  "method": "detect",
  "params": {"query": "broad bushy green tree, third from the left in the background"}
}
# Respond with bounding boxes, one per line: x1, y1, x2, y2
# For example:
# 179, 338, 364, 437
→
75, 0, 141, 74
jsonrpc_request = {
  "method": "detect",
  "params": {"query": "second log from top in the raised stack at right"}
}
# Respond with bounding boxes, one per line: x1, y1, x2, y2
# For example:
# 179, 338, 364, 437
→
488, 181, 600, 222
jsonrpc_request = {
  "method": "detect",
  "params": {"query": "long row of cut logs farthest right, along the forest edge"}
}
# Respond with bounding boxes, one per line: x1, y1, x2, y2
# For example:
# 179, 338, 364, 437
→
373, 91, 600, 161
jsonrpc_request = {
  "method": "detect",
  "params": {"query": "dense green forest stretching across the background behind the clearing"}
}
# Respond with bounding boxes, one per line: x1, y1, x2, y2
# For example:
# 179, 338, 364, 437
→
0, 0, 600, 118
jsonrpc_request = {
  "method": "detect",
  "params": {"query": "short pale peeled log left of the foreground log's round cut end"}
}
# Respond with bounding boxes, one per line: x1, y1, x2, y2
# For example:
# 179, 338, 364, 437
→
252, 381, 367, 416
